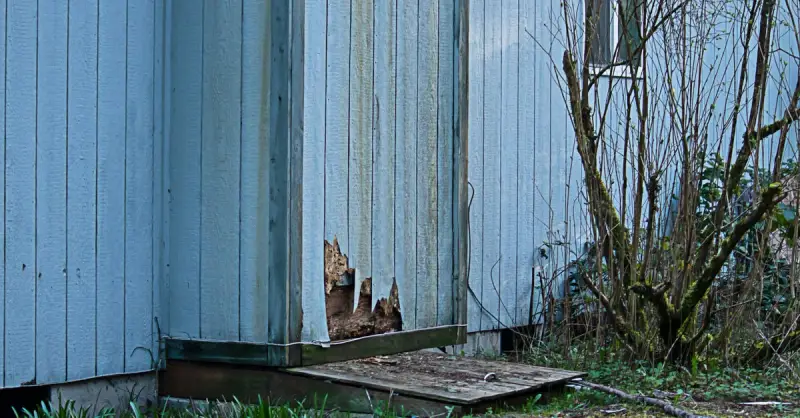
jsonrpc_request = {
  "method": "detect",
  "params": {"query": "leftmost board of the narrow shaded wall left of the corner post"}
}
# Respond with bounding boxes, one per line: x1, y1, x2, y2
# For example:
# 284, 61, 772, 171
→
169, 1, 206, 338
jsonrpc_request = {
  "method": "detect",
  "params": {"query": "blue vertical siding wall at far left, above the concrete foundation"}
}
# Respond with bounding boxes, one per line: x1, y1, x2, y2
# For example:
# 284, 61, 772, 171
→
0, 0, 164, 387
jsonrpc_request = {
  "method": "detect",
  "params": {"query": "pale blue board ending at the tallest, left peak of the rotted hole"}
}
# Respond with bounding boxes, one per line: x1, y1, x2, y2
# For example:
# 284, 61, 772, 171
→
319, 0, 350, 255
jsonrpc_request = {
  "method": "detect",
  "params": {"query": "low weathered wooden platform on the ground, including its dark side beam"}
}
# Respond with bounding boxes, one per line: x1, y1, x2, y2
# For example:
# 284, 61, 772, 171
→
159, 352, 585, 416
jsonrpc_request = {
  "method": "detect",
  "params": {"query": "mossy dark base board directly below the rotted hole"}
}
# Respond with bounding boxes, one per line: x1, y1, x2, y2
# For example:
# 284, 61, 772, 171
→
301, 325, 466, 366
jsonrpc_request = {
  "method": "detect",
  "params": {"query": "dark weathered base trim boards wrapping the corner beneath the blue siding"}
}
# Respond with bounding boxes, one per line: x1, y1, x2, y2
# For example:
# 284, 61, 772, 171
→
164, 325, 467, 367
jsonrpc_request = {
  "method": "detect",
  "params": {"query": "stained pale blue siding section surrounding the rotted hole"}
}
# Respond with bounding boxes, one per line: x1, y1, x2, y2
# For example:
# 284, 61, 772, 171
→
303, 0, 457, 340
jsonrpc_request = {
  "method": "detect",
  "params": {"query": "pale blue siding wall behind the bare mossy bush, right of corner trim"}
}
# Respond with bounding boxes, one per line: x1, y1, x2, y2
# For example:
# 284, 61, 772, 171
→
468, 0, 798, 331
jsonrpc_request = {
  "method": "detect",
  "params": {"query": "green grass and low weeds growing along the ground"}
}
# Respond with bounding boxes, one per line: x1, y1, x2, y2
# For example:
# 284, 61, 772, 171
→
18, 346, 800, 418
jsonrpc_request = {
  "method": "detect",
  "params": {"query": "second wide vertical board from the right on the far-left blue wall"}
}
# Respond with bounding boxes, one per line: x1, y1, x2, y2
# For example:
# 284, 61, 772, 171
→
97, 1, 127, 374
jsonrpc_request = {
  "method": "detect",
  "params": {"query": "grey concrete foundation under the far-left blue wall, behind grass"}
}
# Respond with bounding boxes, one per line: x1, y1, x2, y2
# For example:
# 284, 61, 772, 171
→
50, 372, 158, 416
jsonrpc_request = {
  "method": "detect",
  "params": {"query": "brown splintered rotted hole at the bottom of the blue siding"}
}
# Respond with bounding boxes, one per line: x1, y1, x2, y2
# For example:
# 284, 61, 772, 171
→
325, 237, 403, 341
